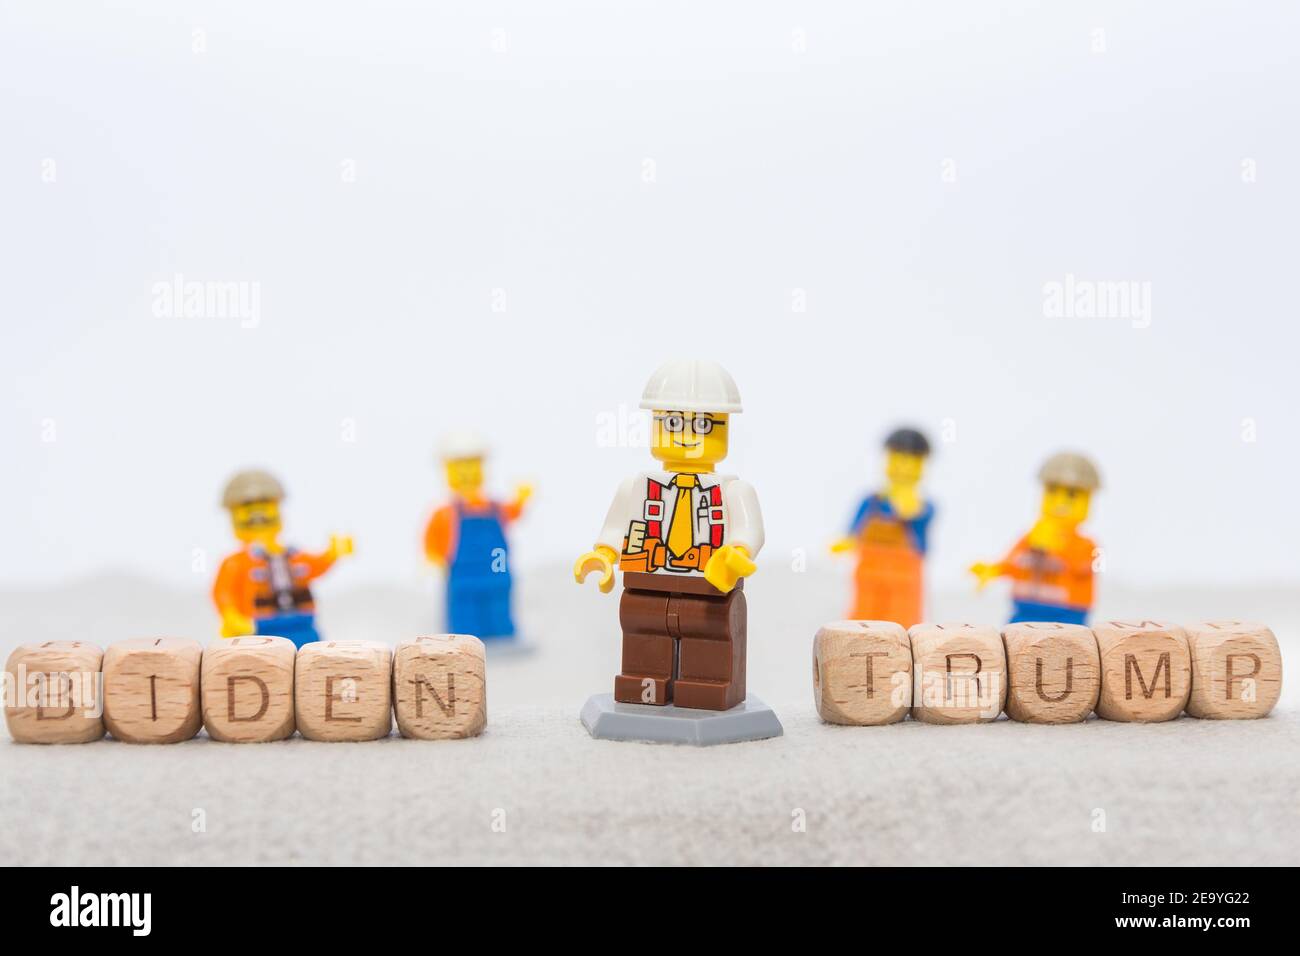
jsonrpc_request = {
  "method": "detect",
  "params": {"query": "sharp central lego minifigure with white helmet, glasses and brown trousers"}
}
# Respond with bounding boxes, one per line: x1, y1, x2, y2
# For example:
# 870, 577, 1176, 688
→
573, 360, 759, 712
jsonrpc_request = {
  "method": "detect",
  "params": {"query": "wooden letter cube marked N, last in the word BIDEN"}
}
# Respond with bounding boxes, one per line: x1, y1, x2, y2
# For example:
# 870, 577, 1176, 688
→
393, 633, 488, 740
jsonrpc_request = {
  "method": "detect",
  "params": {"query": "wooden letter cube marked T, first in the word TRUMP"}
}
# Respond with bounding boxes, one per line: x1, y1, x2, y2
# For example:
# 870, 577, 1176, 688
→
813, 620, 911, 726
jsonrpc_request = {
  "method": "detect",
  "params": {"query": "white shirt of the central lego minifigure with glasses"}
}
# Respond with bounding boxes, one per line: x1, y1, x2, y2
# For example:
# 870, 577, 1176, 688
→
595, 471, 763, 558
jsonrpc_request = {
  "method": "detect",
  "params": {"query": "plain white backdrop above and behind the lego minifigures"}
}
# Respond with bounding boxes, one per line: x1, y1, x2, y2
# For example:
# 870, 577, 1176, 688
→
0, 0, 1300, 587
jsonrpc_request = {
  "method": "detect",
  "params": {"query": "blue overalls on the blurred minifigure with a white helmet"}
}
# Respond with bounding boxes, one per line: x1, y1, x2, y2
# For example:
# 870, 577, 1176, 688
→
447, 503, 515, 640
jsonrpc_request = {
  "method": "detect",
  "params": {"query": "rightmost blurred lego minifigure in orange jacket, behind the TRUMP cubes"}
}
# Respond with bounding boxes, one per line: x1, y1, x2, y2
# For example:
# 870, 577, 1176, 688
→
970, 453, 1101, 624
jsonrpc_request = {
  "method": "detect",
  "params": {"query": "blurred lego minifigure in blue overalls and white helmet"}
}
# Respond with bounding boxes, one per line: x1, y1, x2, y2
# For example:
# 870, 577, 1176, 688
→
424, 434, 533, 640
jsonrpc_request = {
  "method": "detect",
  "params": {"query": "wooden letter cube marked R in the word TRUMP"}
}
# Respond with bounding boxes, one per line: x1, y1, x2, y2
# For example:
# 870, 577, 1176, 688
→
909, 623, 1006, 723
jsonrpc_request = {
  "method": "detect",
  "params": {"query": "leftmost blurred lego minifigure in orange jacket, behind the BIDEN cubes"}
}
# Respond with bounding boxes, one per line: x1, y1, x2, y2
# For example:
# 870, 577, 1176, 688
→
212, 470, 352, 648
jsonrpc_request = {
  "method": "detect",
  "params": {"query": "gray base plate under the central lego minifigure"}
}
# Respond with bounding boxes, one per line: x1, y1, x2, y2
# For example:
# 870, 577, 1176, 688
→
582, 693, 783, 747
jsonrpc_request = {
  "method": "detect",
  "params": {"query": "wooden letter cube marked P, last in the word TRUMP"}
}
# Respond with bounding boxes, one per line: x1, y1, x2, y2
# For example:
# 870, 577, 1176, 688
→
1187, 620, 1282, 719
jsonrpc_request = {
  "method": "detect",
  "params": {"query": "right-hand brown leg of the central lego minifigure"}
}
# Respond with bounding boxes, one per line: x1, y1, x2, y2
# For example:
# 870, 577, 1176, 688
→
668, 589, 746, 710
